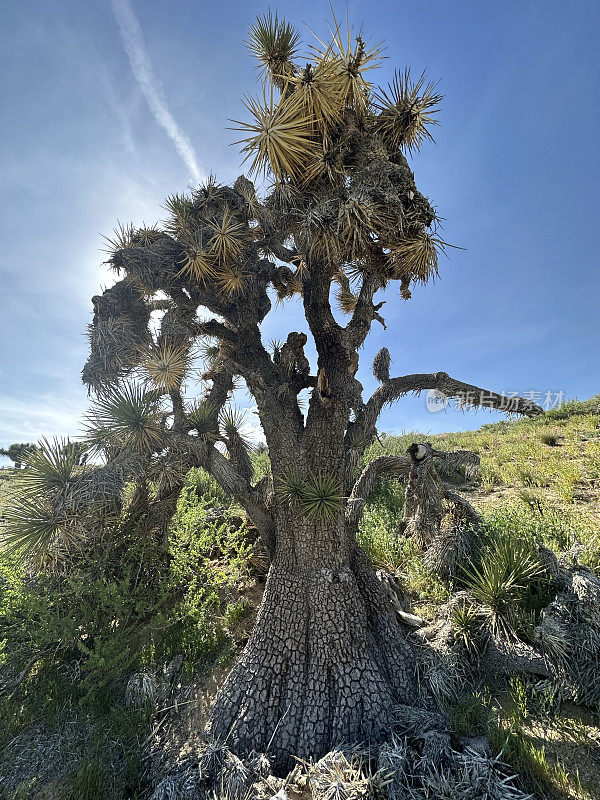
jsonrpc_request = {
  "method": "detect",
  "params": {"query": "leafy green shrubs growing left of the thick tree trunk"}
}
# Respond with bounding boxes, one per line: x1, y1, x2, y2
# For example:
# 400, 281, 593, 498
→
0, 471, 249, 800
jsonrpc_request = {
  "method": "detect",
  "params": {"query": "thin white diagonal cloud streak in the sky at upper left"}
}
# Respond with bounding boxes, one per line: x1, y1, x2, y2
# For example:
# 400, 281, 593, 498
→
112, 0, 205, 183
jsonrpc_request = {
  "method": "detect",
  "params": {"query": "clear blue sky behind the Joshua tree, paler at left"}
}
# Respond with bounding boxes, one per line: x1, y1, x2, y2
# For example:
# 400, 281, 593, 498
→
0, 0, 600, 454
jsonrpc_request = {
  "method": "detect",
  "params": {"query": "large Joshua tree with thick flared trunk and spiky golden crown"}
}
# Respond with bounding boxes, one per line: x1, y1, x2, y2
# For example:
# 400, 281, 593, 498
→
4, 15, 541, 769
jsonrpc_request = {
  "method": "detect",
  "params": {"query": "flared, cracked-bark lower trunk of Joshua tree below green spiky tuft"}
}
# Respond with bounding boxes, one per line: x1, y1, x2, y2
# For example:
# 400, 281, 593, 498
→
210, 523, 414, 773
